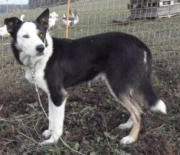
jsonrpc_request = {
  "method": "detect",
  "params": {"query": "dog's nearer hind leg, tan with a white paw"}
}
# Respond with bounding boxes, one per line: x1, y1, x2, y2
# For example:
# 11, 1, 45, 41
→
106, 80, 142, 144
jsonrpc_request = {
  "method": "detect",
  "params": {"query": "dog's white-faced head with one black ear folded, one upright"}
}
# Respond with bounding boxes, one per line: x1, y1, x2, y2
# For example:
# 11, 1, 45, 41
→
4, 9, 49, 57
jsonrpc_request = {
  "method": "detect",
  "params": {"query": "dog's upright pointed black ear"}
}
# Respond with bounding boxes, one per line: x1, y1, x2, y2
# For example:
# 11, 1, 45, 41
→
36, 9, 49, 29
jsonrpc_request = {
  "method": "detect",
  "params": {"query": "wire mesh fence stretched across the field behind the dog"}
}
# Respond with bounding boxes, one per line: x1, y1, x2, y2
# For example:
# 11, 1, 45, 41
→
0, 0, 180, 101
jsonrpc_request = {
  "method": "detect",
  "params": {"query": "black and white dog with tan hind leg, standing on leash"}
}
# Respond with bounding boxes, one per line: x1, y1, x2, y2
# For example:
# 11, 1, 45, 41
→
4, 9, 166, 144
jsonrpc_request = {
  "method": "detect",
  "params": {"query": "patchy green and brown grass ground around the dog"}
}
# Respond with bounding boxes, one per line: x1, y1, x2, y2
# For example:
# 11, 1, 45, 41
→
0, 0, 180, 155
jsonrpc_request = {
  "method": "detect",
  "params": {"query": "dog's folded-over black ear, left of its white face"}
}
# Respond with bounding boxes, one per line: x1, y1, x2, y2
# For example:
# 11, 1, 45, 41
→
4, 17, 22, 35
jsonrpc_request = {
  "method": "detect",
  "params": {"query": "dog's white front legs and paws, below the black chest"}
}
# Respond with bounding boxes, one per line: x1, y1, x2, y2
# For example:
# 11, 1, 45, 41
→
41, 90, 67, 145
